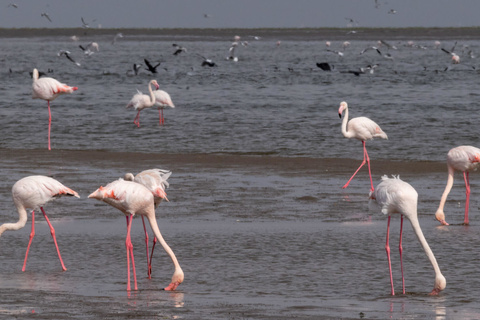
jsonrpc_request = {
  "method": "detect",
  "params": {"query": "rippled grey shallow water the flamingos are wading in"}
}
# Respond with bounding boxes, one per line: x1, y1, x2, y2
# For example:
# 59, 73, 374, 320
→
0, 29, 480, 319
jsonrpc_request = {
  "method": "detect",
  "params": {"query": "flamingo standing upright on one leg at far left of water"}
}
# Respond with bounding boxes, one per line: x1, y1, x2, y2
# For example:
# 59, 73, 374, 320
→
32, 69, 78, 150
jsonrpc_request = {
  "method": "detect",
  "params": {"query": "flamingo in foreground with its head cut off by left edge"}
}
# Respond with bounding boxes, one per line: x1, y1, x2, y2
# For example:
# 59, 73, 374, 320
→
0, 176, 80, 271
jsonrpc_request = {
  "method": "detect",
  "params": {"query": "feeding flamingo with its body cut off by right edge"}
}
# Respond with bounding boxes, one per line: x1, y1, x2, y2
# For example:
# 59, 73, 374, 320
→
435, 146, 480, 226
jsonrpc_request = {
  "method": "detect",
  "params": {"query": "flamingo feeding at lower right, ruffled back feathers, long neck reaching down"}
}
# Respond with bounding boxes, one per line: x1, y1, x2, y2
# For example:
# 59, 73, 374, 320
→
369, 176, 447, 296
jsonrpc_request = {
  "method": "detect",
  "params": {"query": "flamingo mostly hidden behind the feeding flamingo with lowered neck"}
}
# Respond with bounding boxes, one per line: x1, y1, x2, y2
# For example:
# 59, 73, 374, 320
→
124, 169, 172, 279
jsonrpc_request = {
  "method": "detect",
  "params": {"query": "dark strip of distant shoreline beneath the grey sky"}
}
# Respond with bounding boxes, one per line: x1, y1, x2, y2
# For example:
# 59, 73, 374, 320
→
0, 27, 480, 41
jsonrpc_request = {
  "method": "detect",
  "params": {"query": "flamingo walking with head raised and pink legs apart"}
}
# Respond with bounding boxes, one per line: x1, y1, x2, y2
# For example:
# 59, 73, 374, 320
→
338, 101, 388, 191
